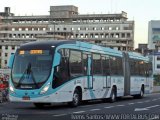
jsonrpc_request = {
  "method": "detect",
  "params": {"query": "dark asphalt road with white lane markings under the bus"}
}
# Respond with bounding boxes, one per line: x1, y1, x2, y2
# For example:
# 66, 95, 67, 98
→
0, 93, 160, 120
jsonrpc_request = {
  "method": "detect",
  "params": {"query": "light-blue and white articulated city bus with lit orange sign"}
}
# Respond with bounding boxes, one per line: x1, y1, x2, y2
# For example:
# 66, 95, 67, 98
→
8, 40, 153, 107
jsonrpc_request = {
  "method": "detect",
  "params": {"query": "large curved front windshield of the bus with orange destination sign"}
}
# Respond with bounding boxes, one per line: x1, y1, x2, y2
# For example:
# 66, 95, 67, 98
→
12, 50, 52, 88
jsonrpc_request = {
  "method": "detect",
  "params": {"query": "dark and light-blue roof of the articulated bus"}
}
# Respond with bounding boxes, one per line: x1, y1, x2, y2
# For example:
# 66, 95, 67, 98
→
20, 40, 149, 61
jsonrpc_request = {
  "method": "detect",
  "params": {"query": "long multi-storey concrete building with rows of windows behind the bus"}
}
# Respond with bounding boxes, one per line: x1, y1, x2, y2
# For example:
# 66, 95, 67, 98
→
0, 5, 134, 67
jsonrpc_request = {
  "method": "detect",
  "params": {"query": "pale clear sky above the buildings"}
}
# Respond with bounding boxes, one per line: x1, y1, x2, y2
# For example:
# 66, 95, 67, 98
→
0, 0, 160, 48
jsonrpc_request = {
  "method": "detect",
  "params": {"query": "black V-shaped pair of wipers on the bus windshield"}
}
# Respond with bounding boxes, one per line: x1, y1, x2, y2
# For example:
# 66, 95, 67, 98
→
17, 63, 39, 88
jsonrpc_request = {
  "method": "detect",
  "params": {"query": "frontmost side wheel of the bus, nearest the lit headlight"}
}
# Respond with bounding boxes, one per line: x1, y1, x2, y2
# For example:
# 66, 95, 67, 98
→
69, 89, 81, 107
